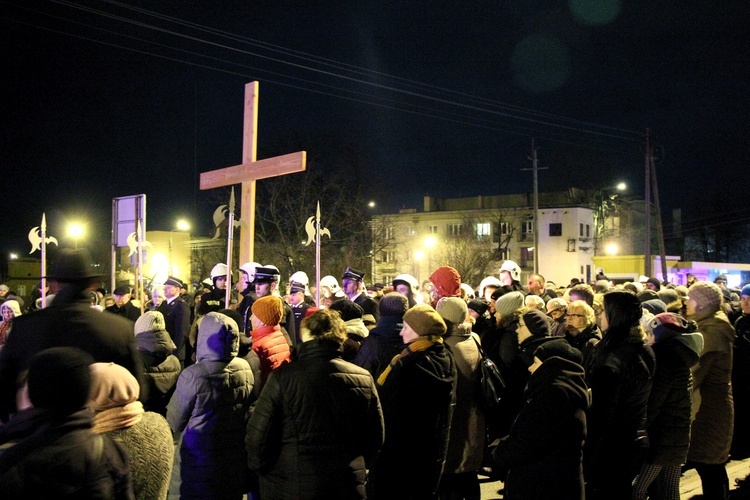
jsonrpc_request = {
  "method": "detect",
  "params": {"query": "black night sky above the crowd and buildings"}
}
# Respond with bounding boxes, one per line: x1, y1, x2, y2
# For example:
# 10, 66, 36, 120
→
0, 0, 750, 255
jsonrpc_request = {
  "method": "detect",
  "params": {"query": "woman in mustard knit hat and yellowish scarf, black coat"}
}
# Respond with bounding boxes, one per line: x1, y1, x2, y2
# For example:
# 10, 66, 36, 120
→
368, 304, 456, 498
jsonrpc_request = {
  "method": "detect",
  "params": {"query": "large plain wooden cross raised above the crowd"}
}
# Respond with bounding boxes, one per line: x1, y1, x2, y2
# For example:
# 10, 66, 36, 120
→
200, 82, 307, 265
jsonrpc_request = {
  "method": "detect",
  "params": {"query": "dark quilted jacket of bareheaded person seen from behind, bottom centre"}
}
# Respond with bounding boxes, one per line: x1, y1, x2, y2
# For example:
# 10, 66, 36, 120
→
245, 340, 384, 499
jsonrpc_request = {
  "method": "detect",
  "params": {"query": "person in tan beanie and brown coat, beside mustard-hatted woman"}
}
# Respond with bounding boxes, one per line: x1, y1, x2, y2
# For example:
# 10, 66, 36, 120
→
437, 297, 486, 498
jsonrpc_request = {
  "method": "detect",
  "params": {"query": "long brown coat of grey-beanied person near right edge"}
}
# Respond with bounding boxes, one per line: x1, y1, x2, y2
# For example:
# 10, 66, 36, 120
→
688, 311, 736, 464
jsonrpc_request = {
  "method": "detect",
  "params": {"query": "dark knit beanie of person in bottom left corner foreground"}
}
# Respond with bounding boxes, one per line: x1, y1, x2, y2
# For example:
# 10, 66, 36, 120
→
28, 347, 94, 416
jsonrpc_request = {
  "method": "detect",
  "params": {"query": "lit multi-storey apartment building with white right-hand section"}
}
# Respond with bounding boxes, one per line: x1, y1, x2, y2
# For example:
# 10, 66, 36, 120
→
371, 190, 614, 287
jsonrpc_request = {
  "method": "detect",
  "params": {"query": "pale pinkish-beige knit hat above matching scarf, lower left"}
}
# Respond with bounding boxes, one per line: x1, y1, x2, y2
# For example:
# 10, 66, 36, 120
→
89, 363, 141, 411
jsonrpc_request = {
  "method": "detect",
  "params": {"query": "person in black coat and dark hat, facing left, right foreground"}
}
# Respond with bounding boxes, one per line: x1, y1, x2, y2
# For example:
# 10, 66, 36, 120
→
491, 338, 589, 499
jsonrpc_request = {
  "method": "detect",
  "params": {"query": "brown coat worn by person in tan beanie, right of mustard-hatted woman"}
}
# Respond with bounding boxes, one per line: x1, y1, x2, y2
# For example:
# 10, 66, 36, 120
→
444, 322, 485, 474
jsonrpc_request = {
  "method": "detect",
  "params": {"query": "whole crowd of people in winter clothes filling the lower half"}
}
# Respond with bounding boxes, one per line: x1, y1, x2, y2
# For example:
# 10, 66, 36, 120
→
0, 249, 750, 500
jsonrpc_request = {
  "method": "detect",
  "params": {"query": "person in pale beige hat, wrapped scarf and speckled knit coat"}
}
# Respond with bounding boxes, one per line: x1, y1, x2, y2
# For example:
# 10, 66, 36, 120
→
88, 363, 174, 499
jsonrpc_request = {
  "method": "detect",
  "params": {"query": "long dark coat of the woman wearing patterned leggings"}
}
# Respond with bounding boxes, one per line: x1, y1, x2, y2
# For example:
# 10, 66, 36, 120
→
646, 332, 703, 466
